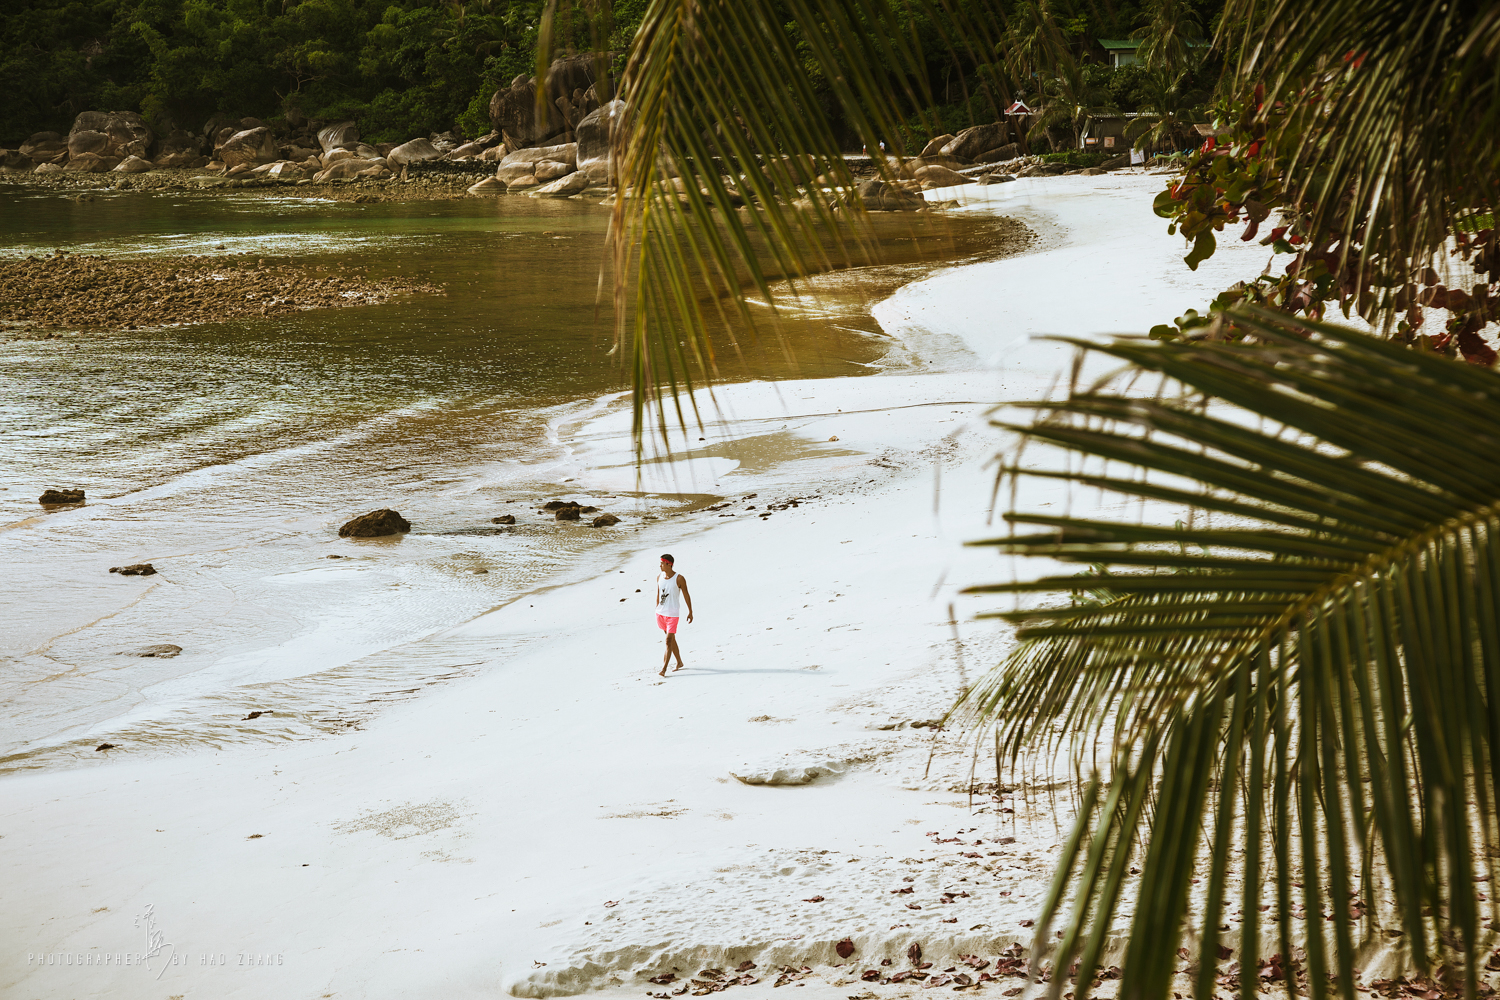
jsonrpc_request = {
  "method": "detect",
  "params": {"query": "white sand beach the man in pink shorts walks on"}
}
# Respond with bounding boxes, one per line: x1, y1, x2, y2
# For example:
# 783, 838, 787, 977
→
0, 174, 1290, 1000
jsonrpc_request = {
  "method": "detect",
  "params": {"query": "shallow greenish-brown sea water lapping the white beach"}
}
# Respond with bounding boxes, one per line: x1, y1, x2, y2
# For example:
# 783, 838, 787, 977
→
0, 192, 1007, 771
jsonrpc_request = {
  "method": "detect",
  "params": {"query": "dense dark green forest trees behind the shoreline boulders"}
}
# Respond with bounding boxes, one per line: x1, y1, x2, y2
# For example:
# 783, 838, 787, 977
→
0, 0, 1223, 144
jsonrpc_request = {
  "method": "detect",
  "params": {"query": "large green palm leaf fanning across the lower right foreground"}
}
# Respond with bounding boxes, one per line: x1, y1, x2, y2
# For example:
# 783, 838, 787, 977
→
956, 302, 1500, 1000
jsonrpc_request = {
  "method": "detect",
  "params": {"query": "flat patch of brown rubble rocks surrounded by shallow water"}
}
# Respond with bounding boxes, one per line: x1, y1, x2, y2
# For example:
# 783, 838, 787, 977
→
0, 252, 443, 336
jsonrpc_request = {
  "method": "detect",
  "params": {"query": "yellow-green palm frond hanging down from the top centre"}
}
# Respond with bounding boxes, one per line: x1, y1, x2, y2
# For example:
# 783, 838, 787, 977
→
600, 0, 926, 447
